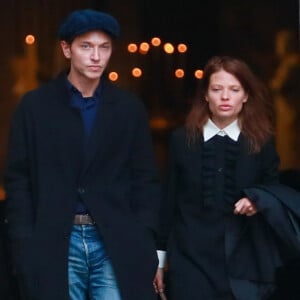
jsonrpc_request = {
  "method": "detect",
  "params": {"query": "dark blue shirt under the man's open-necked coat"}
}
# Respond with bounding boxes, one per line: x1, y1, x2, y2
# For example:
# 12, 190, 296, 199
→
68, 81, 101, 214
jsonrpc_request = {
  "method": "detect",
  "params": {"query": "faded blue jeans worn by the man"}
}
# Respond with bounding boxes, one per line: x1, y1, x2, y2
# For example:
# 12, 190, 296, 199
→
69, 225, 121, 300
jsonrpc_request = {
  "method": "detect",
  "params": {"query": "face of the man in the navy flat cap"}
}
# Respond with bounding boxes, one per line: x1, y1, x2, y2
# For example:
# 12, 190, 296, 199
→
61, 31, 112, 81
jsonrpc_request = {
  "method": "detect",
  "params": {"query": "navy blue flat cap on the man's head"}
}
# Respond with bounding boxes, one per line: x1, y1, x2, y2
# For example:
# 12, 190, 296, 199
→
58, 9, 120, 42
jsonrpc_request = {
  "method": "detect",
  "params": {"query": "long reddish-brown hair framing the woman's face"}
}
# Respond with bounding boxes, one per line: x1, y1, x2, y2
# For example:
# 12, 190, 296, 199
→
186, 56, 274, 153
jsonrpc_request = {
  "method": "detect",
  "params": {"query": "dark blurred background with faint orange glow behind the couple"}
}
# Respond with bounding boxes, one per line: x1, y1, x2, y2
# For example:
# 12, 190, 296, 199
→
0, 0, 300, 300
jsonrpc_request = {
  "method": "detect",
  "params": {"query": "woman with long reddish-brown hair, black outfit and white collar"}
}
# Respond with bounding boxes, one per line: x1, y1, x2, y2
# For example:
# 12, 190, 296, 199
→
154, 56, 288, 300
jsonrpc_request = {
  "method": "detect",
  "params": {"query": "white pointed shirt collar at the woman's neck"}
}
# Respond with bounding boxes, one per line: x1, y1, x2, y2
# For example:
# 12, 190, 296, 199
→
203, 119, 241, 142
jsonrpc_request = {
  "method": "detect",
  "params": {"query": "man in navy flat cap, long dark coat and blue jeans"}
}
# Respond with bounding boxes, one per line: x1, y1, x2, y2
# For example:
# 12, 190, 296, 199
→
5, 10, 160, 300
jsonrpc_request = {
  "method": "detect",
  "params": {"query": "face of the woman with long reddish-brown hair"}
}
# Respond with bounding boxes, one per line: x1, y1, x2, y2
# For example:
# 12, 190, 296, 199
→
205, 70, 248, 128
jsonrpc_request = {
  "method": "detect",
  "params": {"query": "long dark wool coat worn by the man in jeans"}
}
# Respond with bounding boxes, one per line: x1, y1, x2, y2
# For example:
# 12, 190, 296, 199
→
5, 74, 160, 300
